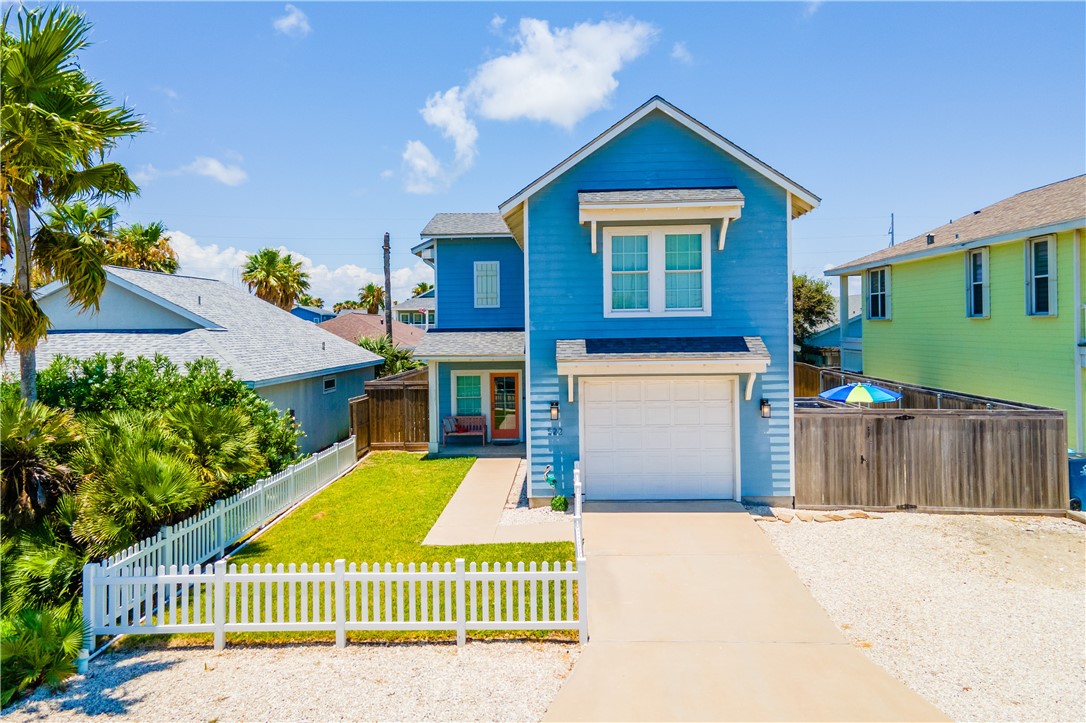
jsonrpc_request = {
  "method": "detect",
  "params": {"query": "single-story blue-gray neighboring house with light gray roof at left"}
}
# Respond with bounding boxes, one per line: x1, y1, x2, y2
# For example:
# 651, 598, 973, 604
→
3, 266, 383, 453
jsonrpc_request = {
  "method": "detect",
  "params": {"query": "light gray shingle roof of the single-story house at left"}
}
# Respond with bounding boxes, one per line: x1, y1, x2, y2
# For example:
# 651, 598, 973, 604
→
3, 266, 381, 384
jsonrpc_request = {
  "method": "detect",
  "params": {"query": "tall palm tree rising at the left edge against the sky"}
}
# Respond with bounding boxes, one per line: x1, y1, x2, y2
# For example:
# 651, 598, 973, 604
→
0, 5, 146, 402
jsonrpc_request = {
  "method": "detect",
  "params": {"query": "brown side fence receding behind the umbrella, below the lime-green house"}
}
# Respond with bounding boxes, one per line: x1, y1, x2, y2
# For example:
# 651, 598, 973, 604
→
792, 362, 1046, 410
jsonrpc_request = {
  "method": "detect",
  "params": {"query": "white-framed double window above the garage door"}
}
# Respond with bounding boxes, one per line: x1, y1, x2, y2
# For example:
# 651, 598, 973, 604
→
604, 226, 710, 317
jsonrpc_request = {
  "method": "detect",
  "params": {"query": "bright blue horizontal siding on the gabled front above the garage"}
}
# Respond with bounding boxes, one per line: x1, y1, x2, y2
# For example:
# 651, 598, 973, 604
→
521, 113, 792, 496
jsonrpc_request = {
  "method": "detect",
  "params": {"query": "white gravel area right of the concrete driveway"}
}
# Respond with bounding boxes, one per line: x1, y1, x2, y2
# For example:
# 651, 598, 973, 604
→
761, 512, 1086, 721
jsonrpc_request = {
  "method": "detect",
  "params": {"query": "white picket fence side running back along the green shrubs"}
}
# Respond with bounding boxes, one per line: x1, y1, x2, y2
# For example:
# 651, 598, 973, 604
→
91, 436, 355, 574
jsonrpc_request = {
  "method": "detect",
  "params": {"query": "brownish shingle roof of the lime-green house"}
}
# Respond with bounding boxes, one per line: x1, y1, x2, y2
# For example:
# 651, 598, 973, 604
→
826, 176, 1086, 275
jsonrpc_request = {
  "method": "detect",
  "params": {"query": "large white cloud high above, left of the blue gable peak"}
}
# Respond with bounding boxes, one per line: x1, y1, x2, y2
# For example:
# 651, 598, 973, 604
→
403, 15, 651, 193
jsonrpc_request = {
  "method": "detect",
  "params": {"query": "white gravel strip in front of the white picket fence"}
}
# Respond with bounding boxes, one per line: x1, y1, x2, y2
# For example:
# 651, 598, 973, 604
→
4, 642, 579, 721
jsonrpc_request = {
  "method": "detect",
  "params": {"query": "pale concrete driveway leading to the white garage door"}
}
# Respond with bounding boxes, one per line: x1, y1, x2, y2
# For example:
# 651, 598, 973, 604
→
544, 503, 946, 721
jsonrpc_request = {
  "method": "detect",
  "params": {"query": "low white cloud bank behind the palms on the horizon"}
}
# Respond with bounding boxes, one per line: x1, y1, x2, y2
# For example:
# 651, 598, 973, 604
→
169, 231, 433, 308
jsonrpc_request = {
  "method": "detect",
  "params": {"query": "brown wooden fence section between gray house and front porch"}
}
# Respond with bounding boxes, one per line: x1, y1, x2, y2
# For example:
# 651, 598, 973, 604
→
351, 369, 430, 452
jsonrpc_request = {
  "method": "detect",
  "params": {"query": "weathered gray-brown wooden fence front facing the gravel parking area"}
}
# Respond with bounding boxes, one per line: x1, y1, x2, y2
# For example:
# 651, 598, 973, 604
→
794, 408, 1068, 512
